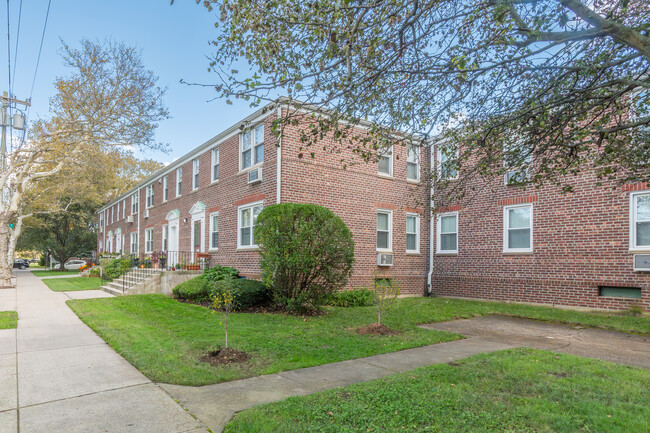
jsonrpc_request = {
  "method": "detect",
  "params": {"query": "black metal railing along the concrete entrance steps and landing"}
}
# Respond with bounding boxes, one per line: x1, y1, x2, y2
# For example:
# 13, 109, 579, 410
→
101, 251, 210, 293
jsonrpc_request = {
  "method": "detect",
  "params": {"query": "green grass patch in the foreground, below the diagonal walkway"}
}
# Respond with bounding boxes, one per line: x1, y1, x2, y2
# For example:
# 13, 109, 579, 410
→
225, 349, 650, 433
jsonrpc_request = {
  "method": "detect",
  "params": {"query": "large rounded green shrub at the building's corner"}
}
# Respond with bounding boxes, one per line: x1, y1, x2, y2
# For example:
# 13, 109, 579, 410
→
255, 203, 354, 310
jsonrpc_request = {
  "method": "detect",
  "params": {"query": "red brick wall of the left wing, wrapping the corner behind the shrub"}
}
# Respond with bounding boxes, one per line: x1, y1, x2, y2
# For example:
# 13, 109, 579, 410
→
99, 107, 429, 294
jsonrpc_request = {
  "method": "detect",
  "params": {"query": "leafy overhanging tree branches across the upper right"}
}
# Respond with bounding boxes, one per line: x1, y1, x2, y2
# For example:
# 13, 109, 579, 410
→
192, 0, 650, 194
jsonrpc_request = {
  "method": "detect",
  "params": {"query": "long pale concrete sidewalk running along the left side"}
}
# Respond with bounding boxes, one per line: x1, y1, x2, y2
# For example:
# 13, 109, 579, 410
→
0, 272, 206, 433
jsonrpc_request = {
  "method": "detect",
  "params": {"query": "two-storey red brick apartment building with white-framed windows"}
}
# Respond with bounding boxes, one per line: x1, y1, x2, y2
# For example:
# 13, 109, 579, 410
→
98, 99, 650, 310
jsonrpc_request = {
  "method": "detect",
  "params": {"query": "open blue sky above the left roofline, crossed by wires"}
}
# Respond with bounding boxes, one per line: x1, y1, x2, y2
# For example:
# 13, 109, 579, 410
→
0, 0, 264, 162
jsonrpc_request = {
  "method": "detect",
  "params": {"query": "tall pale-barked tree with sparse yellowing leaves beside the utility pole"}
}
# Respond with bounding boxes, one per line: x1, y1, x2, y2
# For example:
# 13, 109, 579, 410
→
0, 40, 168, 286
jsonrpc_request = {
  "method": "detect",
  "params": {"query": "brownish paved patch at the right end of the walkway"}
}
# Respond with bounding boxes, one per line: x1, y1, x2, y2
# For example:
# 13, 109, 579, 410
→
422, 316, 650, 369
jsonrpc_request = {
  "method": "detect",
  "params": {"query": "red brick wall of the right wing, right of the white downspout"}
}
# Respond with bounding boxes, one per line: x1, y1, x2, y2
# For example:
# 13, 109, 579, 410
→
433, 156, 650, 310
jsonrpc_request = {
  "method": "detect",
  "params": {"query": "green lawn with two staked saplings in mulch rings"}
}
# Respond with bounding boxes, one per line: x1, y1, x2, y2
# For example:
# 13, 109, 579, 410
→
68, 295, 650, 385
